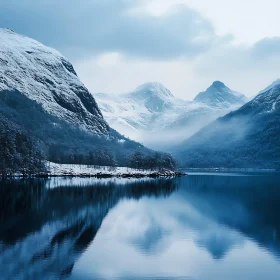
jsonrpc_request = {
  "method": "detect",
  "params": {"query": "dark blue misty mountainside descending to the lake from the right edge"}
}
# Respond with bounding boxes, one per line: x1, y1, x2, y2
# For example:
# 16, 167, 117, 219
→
173, 81, 280, 168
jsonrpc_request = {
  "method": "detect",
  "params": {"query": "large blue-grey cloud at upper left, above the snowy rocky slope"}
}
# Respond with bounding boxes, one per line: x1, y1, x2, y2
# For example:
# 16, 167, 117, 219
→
0, 0, 220, 59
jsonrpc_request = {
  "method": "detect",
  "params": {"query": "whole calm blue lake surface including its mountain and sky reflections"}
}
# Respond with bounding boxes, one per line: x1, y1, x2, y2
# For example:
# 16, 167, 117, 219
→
0, 173, 280, 280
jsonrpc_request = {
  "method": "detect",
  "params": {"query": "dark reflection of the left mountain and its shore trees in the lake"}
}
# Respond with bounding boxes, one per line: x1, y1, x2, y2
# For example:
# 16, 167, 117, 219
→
0, 179, 176, 279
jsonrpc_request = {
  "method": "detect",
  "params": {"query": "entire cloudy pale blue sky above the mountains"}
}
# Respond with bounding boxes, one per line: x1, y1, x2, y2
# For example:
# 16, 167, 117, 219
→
0, 0, 280, 100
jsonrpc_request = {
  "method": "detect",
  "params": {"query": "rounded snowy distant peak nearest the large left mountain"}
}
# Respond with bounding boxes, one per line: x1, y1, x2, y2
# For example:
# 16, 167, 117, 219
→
94, 83, 180, 138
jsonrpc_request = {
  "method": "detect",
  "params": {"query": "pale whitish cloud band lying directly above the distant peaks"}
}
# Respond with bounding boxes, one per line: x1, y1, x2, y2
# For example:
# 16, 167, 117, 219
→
74, 32, 280, 100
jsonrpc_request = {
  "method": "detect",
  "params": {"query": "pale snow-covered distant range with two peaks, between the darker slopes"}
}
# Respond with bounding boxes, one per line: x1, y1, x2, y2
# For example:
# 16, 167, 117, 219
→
94, 82, 246, 148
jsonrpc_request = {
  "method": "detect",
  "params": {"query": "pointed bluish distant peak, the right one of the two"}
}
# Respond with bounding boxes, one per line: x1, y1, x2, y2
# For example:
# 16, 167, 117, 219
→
194, 81, 247, 108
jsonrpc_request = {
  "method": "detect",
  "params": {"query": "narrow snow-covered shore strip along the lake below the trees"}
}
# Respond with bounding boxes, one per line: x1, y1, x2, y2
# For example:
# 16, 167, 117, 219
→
45, 162, 185, 178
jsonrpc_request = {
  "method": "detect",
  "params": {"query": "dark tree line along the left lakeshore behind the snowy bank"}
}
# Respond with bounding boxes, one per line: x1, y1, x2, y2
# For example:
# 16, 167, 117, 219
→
0, 117, 177, 177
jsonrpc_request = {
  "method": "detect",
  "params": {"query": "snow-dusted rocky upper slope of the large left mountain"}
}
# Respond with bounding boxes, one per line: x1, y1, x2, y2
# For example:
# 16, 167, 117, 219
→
0, 28, 110, 136
